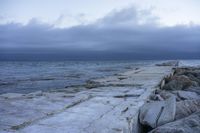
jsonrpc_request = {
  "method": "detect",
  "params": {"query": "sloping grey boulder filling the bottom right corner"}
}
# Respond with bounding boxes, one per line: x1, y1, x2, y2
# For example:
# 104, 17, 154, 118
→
150, 112, 200, 133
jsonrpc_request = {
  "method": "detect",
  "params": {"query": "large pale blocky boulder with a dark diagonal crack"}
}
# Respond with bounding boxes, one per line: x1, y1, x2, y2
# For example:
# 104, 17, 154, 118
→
139, 97, 176, 128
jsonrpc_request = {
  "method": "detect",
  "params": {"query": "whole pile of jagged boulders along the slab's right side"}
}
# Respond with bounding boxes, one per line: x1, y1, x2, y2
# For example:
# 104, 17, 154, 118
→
139, 64, 200, 133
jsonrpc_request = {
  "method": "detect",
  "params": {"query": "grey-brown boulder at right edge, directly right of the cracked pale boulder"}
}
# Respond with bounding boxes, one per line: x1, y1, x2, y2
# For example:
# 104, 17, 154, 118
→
175, 100, 200, 120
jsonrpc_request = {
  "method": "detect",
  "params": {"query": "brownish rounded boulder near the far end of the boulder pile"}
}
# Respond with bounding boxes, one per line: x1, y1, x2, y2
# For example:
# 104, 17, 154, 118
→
163, 75, 198, 90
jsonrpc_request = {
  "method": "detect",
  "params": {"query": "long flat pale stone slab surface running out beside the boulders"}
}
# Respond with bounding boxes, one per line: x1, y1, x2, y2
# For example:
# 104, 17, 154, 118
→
0, 66, 172, 133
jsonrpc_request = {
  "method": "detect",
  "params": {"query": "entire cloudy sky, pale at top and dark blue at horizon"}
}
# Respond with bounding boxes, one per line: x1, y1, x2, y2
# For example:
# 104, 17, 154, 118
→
0, 0, 200, 60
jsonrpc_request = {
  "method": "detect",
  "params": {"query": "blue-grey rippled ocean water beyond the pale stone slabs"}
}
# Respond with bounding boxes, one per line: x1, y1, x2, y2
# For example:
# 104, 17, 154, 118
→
0, 60, 200, 94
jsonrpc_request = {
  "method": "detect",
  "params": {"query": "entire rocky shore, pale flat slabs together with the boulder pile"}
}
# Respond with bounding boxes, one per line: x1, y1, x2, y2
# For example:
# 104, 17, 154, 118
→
0, 61, 200, 133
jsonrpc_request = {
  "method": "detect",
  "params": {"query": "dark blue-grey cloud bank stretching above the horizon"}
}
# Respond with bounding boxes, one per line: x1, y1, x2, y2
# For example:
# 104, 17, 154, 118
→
0, 8, 200, 60
